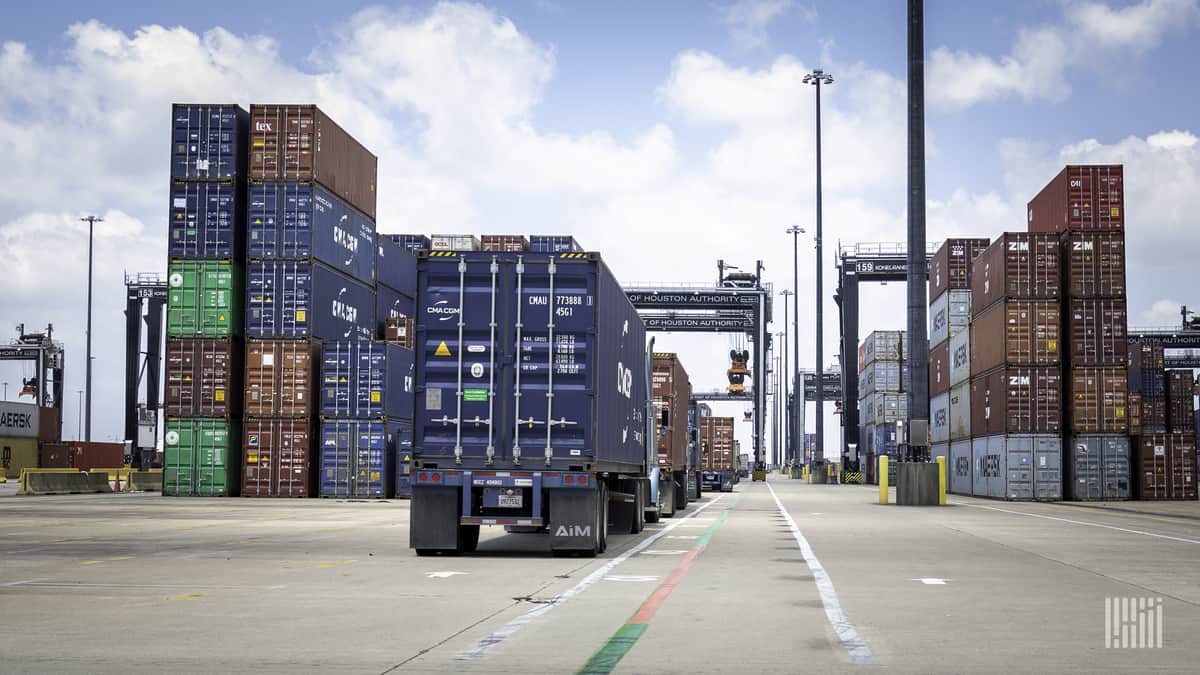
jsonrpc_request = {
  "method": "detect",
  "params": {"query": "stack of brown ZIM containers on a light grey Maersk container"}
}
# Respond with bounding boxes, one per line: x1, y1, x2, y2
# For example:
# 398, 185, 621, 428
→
952, 232, 1062, 500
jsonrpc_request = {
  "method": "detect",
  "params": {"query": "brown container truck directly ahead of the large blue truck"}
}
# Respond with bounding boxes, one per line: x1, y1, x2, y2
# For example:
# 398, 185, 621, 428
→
650, 353, 697, 515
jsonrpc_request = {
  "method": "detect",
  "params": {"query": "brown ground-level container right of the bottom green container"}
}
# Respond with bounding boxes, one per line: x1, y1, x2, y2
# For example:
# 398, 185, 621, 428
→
241, 418, 314, 497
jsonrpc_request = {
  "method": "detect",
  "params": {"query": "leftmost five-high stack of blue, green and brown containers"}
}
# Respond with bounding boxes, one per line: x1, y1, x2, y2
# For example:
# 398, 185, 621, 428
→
162, 103, 250, 496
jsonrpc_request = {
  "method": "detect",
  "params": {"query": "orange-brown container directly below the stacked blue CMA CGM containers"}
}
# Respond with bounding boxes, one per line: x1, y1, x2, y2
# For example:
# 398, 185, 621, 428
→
246, 340, 320, 417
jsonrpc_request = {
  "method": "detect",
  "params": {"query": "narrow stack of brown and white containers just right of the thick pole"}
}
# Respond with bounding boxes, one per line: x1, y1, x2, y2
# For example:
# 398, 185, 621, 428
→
929, 239, 990, 494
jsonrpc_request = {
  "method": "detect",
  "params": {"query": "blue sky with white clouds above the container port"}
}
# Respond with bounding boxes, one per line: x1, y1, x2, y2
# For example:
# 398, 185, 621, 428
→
0, 0, 1200, 454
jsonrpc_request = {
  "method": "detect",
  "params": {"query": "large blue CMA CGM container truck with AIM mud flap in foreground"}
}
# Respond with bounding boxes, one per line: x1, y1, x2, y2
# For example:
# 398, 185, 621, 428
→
409, 251, 658, 555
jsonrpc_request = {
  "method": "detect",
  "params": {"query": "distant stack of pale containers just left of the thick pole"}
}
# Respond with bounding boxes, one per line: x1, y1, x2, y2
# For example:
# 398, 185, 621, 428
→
858, 330, 902, 477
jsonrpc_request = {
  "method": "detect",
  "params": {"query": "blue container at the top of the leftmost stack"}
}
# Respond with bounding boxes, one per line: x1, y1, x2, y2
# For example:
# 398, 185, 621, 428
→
170, 103, 250, 181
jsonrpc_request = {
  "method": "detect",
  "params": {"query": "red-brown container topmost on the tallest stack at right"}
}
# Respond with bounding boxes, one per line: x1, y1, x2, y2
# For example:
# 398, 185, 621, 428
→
1028, 165, 1124, 232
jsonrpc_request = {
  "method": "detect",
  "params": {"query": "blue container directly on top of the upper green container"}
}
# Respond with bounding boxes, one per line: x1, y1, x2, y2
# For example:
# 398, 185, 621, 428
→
167, 180, 246, 259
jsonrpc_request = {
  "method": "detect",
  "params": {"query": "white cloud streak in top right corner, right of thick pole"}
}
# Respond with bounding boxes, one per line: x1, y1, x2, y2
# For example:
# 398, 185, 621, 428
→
925, 0, 1198, 109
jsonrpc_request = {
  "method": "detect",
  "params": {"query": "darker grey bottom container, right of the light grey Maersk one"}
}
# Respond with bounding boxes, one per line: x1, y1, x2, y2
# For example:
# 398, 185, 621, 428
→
1064, 435, 1132, 502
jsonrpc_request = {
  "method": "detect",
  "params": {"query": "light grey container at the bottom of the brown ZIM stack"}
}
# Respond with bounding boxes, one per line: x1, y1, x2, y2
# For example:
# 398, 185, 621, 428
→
971, 435, 1062, 501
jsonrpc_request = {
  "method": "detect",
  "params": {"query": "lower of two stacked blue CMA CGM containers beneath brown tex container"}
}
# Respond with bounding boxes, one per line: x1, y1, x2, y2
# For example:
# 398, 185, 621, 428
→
246, 261, 376, 340
